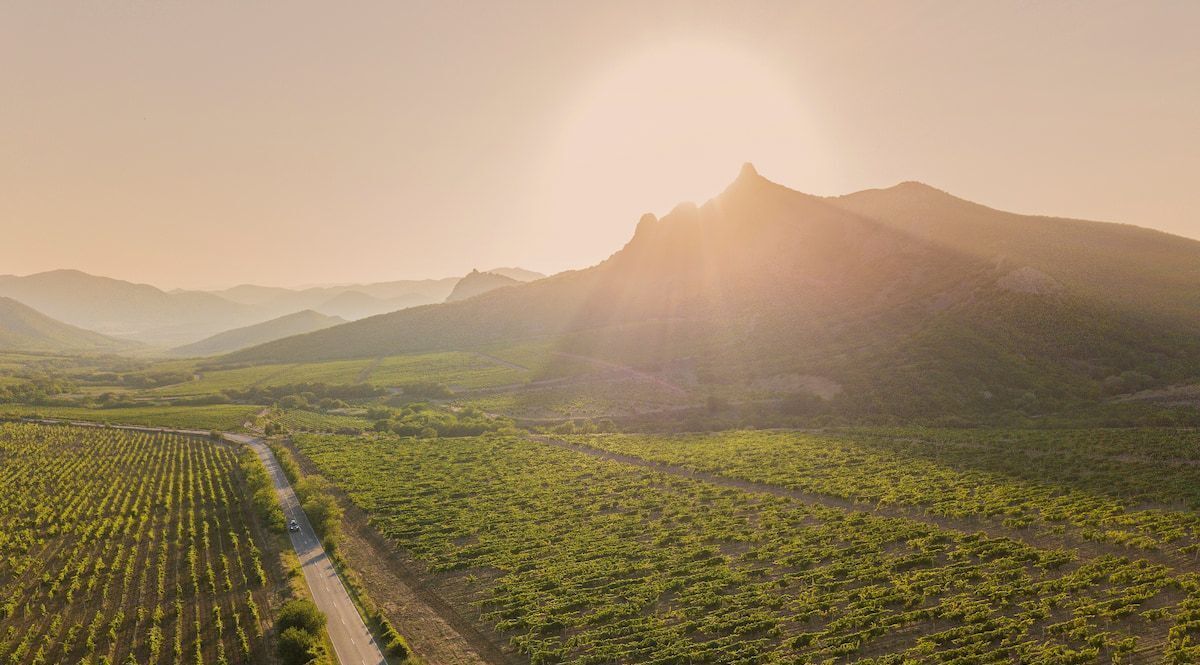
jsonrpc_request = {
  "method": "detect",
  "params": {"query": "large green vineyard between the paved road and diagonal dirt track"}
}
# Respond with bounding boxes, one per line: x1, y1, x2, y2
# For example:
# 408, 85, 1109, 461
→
296, 435, 1200, 664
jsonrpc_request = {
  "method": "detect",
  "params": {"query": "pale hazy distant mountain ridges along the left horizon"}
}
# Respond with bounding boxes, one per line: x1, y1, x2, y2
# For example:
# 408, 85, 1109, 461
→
0, 269, 540, 351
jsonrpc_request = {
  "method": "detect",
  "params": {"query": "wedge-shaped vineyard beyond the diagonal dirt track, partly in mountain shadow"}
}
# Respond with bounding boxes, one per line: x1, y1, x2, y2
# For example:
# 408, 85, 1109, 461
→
571, 430, 1200, 552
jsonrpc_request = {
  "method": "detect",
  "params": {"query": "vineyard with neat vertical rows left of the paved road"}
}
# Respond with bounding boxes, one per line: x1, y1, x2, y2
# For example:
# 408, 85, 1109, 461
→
0, 423, 281, 665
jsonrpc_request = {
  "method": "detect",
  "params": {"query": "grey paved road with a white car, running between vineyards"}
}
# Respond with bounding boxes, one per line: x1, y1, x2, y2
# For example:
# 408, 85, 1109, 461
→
224, 433, 388, 665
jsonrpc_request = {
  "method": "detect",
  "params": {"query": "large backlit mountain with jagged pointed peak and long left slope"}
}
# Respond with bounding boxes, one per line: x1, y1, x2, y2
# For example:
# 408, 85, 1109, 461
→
228, 164, 1200, 415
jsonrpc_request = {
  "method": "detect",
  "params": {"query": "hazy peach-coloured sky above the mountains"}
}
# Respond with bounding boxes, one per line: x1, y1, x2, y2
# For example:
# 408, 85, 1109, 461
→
0, 0, 1200, 287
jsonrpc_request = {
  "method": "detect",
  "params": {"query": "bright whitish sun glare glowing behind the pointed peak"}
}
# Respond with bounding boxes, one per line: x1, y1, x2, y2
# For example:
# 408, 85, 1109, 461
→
544, 43, 816, 230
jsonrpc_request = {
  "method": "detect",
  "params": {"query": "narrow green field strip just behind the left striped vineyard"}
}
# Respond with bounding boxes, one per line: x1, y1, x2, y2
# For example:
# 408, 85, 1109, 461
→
0, 405, 262, 431
